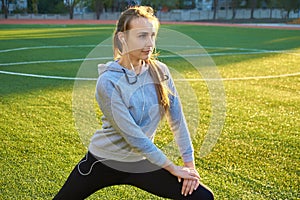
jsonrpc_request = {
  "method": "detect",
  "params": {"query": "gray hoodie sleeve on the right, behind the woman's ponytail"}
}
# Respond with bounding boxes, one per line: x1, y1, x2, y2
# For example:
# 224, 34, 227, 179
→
164, 66, 194, 162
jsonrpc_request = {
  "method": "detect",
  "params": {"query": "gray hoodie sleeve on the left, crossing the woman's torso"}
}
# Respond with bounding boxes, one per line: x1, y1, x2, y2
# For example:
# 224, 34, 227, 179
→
96, 76, 171, 167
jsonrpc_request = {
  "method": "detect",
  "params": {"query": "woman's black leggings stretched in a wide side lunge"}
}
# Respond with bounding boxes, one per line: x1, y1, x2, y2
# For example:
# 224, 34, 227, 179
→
54, 152, 214, 200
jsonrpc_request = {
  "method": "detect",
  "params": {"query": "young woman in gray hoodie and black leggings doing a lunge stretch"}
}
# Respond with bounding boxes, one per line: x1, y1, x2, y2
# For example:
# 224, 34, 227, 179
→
54, 6, 213, 200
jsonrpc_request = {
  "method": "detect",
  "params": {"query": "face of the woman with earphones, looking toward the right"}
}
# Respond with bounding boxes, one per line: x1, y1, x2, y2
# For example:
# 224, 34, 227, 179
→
123, 17, 157, 61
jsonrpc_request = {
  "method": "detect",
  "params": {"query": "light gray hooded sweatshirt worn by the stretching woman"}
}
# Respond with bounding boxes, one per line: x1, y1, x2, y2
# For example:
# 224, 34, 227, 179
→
89, 61, 194, 167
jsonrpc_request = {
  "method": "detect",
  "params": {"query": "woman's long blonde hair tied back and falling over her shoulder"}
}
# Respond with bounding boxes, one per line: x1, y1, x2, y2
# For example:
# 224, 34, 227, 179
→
113, 6, 170, 111
